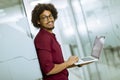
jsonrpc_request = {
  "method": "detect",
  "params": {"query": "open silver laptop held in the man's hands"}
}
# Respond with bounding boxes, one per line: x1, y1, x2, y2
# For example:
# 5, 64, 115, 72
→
75, 36, 105, 66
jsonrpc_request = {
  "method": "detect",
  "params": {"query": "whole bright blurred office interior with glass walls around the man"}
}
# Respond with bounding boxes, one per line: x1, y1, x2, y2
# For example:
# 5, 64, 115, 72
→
0, 0, 120, 80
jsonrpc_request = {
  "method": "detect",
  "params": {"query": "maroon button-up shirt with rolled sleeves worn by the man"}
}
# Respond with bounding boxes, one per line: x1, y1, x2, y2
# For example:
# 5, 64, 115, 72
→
34, 29, 68, 80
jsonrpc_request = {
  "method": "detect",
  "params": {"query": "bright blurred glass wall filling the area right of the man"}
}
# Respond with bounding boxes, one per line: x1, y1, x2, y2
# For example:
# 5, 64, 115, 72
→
53, 0, 120, 80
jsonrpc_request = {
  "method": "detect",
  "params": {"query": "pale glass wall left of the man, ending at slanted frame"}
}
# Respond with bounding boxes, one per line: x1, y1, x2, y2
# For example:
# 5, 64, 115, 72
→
0, 0, 42, 80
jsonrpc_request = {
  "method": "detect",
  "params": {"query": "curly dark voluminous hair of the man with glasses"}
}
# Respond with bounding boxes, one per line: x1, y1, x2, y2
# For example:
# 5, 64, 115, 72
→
31, 3, 58, 28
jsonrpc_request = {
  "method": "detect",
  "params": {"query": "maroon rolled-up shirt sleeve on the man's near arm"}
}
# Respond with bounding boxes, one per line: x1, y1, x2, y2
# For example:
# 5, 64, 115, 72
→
35, 35, 54, 74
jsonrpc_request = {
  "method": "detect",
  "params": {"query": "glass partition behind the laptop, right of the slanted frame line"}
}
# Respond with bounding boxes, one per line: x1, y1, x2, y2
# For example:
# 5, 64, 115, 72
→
67, 0, 120, 80
